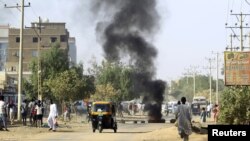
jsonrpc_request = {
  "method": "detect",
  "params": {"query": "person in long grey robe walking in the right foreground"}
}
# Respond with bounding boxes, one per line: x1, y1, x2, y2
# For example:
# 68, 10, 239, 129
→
175, 97, 192, 141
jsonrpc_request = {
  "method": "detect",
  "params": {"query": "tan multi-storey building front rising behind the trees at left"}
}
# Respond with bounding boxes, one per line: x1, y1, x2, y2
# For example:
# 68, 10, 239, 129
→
6, 22, 69, 75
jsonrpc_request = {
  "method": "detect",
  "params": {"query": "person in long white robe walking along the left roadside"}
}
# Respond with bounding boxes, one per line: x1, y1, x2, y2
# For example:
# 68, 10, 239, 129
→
48, 99, 58, 132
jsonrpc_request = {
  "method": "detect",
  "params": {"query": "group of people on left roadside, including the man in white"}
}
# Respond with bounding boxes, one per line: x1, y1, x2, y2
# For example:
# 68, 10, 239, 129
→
0, 96, 58, 131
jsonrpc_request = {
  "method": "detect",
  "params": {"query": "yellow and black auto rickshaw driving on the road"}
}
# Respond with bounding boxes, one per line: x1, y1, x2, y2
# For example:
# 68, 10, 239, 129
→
91, 101, 117, 133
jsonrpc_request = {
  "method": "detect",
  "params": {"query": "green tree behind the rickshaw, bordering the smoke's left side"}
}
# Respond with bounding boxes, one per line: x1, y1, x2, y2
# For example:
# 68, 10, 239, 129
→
91, 61, 135, 101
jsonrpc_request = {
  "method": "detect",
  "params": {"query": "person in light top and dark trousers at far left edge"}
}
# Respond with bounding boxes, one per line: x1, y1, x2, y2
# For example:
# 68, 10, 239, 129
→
0, 96, 9, 131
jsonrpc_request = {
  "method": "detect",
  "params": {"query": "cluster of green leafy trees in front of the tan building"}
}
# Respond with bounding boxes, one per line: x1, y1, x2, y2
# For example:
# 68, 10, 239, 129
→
24, 44, 95, 102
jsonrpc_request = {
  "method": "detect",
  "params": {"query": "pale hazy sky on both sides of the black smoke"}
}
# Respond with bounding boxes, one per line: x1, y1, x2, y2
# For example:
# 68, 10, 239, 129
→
0, 0, 250, 81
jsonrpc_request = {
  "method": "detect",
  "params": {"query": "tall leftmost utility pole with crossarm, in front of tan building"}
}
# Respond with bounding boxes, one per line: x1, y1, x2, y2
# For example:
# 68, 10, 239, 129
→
5, 0, 30, 121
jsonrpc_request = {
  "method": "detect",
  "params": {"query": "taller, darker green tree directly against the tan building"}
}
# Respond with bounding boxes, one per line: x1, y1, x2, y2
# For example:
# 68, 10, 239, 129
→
24, 43, 69, 98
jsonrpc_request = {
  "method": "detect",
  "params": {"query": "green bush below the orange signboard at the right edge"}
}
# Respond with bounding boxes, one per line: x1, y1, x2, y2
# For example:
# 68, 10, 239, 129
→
219, 86, 250, 124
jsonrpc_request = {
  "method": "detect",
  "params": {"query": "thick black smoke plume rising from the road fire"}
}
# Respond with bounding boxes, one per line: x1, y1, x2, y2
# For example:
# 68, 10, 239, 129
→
92, 0, 165, 120
